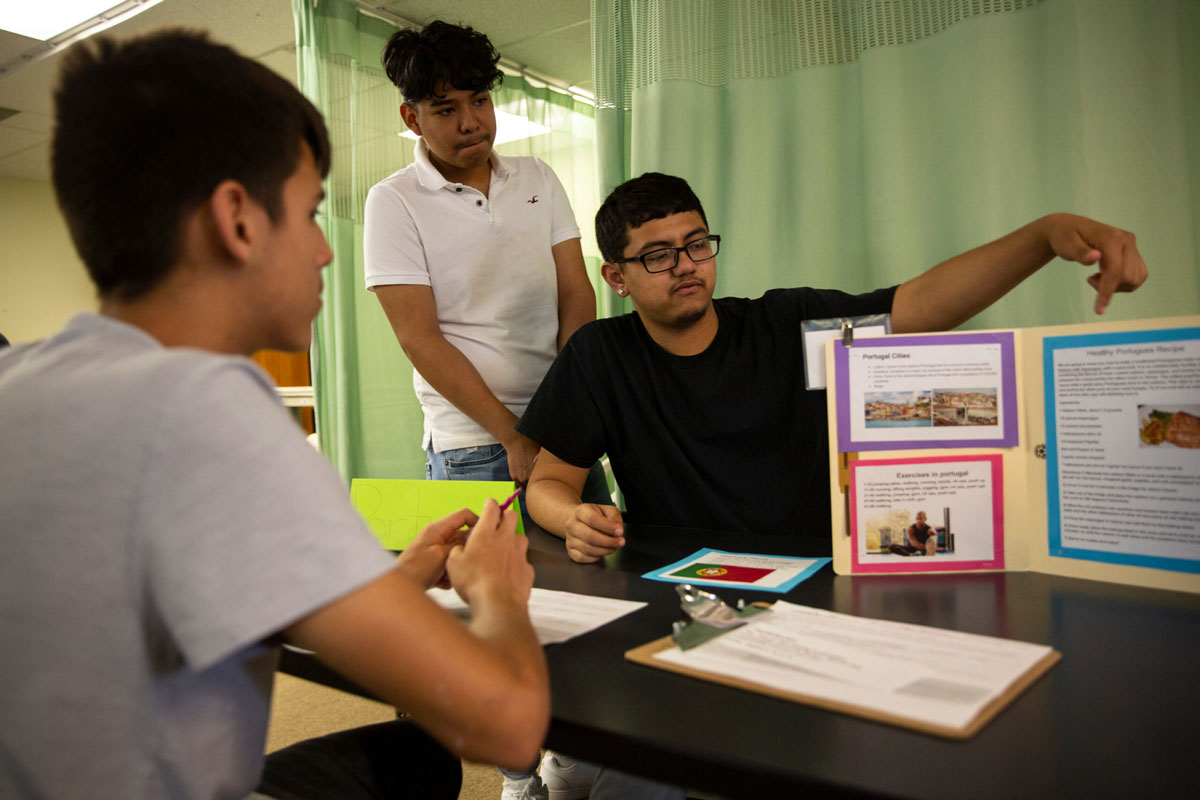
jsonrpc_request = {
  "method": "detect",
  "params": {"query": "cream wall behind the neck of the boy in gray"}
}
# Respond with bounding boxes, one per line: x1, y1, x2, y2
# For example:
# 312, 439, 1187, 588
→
0, 176, 96, 343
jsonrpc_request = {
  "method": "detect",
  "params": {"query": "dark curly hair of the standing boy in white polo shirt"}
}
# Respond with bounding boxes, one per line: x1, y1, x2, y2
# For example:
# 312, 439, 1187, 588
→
383, 19, 504, 103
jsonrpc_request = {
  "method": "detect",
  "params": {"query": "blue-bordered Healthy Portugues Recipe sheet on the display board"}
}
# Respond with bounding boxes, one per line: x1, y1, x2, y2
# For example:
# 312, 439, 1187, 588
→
1043, 327, 1200, 572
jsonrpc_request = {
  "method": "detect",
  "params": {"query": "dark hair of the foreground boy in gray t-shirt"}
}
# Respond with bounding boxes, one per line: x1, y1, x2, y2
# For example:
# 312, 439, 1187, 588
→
50, 30, 330, 300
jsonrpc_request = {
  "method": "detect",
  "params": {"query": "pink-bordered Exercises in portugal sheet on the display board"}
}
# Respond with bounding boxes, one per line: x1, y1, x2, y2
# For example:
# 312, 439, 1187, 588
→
850, 455, 1004, 572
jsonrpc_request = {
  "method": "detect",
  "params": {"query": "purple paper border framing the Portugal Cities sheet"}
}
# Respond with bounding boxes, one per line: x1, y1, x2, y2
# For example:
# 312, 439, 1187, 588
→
833, 331, 1018, 452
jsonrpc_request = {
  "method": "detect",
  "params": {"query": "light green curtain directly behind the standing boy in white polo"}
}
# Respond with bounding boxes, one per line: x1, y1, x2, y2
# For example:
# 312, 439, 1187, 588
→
292, 0, 600, 480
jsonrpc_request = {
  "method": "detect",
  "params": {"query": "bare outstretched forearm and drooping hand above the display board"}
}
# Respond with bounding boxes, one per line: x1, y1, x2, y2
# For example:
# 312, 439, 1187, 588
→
892, 213, 1146, 333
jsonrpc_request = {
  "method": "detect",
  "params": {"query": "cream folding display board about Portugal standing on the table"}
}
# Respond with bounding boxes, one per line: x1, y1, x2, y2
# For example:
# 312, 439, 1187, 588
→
826, 315, 1200, 593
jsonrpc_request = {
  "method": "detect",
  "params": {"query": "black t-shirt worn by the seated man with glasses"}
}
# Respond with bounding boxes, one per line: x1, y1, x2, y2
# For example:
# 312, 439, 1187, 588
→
517, 288, 895, 555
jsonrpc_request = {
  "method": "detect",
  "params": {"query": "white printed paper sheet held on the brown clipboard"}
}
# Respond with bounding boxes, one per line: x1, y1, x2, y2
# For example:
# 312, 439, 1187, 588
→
654, 601, 1050, 729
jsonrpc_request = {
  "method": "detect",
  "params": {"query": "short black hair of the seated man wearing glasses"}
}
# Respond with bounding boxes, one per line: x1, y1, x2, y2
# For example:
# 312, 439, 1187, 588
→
596, 173, 708, 261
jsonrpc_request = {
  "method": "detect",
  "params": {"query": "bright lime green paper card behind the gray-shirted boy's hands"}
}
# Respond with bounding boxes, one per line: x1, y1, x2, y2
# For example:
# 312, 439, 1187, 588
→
350, 477, 524, 551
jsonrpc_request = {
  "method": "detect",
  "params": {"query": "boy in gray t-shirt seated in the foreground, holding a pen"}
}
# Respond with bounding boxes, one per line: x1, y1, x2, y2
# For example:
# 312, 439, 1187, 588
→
0, 31, 548, 798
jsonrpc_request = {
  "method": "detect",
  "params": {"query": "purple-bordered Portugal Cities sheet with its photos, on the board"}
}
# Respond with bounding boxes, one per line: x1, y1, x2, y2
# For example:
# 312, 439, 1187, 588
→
833, 333, 1018, 452
